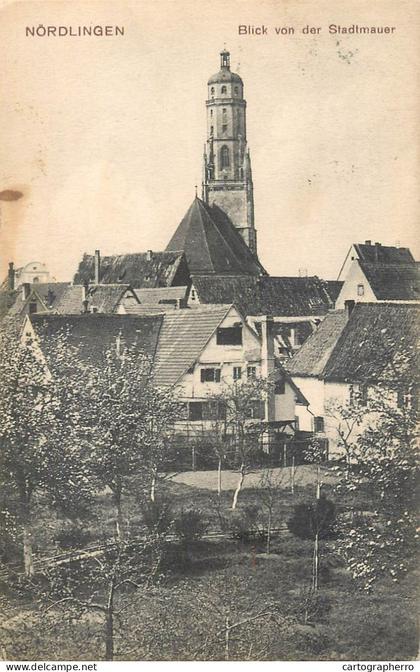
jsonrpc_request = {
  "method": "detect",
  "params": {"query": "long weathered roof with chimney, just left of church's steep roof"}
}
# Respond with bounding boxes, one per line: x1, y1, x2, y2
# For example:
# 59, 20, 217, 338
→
73, 251, 184, 288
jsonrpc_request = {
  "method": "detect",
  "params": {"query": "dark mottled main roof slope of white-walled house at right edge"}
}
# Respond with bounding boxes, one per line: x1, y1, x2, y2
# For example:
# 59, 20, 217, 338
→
324, 303, 420, 383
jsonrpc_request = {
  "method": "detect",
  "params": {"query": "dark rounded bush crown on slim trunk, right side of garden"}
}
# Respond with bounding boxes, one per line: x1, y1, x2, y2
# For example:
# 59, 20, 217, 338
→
287, 495, 336, 539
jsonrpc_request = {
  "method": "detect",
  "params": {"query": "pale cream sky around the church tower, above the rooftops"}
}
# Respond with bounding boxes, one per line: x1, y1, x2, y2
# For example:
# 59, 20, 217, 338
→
0, 0, 420, 280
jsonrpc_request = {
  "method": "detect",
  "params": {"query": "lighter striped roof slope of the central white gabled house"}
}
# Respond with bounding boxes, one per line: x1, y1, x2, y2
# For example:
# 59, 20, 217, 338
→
155, 305, 231, 385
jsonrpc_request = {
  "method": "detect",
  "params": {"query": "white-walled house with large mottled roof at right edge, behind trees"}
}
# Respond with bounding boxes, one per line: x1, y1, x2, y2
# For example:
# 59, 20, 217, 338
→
286, 302, 420, 452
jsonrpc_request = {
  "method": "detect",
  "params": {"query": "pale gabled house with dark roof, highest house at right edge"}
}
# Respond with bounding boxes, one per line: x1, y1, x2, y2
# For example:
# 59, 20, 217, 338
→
335, 240, 420, 309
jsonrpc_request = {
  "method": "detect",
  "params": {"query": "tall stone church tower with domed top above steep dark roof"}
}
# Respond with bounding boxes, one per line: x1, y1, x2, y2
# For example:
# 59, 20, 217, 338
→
202, 50, 257, 255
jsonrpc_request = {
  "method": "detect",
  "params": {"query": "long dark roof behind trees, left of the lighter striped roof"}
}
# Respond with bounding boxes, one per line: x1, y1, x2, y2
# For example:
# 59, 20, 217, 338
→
30, 313, 163, 365
